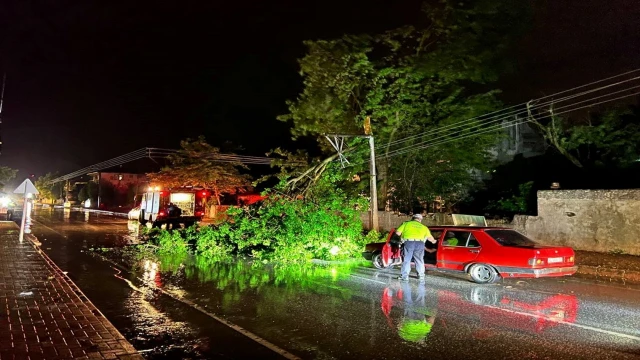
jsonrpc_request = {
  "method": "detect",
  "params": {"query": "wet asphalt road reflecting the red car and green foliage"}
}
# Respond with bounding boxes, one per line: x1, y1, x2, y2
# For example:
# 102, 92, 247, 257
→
32, 210, 640, 359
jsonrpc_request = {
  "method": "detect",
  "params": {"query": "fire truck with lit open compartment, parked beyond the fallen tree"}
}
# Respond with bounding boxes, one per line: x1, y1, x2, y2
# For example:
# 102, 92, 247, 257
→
139, 187, 210, 228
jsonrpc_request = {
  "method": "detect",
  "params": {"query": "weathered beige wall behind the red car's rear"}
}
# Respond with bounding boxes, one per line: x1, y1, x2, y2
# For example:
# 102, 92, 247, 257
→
512, 189, 640, 255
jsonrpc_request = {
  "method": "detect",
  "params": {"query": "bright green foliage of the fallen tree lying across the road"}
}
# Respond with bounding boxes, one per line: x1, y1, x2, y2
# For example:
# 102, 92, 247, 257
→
150, 165, 372, 263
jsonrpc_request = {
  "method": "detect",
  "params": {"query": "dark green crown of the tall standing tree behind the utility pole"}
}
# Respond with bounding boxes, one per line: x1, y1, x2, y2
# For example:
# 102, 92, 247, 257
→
279, 0, 527, 211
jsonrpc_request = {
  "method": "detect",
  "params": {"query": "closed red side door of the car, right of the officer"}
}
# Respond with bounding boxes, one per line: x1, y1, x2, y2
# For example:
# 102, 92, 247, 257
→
438, 229, 481, 271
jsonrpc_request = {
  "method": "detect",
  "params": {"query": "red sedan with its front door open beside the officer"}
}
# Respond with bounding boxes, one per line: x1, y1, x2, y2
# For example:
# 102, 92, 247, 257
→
362, 226, 577, 283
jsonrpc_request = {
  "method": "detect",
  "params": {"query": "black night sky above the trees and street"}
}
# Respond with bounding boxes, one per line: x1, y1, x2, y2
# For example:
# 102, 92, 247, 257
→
0, 0, 640, 186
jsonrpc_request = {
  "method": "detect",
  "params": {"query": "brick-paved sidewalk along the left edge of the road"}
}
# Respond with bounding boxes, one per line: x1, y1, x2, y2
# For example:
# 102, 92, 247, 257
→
0, 222, 142, 360
